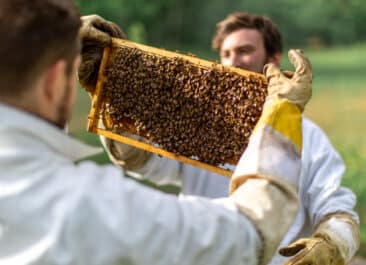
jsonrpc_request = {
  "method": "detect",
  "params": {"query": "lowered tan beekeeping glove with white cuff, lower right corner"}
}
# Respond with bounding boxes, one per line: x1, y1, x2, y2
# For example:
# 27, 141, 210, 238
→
279, 213, 359, 265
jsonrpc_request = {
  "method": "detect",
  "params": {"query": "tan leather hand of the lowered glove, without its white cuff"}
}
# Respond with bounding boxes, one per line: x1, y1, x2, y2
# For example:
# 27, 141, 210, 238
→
279, 234, 345, 265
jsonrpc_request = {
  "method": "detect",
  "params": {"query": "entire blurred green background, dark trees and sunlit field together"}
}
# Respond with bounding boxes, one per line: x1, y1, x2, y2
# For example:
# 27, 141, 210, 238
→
70, 0, 366, 257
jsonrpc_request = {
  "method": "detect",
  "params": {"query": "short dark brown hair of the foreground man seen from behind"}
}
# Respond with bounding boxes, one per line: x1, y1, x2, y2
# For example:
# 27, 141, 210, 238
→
0, 0, 81, 96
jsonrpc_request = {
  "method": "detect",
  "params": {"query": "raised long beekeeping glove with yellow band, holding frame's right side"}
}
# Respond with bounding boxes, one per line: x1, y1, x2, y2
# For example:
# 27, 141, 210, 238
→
230, 50, 312, 264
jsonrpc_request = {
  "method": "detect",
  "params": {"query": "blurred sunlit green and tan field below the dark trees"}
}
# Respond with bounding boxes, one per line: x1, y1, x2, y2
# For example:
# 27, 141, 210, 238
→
70, 44, 366, 257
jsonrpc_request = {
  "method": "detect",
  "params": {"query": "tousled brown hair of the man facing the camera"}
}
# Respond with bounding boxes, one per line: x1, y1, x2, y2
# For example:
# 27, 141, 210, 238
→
212, 12, 282, 57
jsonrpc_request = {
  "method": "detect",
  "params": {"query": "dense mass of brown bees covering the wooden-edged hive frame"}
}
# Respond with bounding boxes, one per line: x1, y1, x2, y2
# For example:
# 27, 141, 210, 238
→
102, 47, 267, 166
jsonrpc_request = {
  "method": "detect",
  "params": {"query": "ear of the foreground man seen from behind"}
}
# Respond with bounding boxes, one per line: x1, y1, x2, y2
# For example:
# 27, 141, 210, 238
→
44, 60, 66, 104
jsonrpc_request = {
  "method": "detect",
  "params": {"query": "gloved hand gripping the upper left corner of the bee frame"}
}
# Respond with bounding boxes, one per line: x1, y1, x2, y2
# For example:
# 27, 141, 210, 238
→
79, 15, 125, 93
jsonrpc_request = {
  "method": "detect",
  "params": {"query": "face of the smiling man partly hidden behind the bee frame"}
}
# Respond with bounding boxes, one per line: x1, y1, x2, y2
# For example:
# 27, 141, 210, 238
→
220, 29, 268, 73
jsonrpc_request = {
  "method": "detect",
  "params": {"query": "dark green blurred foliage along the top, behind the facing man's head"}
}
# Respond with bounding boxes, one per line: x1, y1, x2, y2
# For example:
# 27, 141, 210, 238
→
76, 0, 366, 49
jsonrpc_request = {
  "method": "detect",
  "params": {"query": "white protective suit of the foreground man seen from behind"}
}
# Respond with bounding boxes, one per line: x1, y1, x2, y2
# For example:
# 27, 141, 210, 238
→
0, 101, 300, 265
